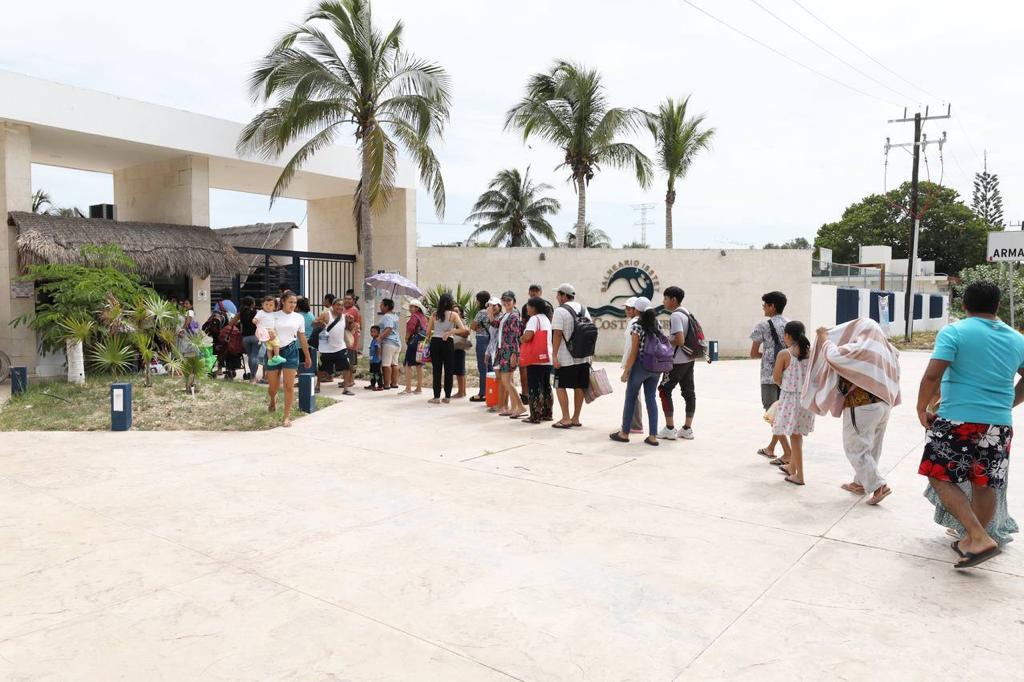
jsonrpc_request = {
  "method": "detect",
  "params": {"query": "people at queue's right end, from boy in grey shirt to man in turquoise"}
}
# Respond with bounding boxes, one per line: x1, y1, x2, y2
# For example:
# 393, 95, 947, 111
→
751, 282, 1024, 568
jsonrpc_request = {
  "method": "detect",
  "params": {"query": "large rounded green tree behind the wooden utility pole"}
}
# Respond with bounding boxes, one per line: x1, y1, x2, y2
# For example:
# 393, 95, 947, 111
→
814, 182, 990, 274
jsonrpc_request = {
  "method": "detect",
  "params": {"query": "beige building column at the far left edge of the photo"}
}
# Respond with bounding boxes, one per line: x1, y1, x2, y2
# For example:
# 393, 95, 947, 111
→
0, 122, 36, 374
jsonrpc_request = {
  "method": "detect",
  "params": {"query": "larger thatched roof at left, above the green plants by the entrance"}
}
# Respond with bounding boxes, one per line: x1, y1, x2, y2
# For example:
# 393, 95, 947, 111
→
7, 212, 247, 278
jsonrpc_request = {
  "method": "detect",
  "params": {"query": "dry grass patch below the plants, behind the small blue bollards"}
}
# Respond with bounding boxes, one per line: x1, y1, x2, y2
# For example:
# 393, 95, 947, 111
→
0, 376, 335, 431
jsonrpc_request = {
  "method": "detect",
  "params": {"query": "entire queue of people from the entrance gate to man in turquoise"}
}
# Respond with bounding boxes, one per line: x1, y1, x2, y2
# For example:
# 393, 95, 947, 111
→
183, 274, 1024, 568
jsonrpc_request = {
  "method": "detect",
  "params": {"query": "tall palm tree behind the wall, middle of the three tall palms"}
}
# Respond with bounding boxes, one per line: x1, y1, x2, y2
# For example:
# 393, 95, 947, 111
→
505, 60, 651, 248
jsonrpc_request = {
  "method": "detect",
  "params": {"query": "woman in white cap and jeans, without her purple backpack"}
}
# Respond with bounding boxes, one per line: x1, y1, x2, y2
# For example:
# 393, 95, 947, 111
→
609, 296, 665, 446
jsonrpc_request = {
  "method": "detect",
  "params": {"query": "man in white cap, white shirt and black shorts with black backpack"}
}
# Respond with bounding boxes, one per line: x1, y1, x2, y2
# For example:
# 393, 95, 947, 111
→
551, 284, 593, 429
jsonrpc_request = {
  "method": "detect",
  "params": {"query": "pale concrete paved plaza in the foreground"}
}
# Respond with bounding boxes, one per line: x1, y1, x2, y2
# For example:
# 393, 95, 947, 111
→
0, 353, 1024, 681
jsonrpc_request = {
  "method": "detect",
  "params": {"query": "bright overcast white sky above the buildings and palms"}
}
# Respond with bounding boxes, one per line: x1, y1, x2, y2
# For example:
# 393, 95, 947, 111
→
0, 0, 1024, 248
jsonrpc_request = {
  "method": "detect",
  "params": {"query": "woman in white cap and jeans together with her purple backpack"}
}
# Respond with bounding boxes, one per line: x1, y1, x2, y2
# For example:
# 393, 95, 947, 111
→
608, 296, 675, 446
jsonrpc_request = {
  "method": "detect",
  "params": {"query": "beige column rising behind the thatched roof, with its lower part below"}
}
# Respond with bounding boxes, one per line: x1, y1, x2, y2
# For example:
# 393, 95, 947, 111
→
114, 156, 210, 324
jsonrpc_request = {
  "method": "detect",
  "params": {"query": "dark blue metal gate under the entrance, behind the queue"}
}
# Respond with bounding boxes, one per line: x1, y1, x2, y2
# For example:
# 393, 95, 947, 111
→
218, 247, 355, 311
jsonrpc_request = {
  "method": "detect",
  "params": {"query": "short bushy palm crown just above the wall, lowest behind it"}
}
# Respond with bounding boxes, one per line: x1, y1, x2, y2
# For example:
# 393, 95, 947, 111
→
466, 168, 562, 247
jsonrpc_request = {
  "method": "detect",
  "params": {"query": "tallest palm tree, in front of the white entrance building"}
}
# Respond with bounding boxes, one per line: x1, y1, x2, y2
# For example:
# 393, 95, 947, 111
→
239, 0, 452, 339
